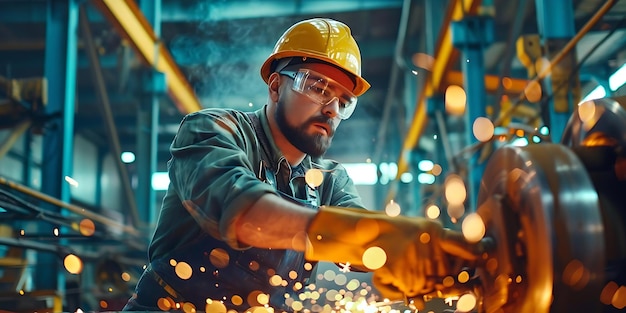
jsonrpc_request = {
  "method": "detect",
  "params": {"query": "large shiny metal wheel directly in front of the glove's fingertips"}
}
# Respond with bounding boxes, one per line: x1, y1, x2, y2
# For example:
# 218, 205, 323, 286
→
477, 144, 605, 313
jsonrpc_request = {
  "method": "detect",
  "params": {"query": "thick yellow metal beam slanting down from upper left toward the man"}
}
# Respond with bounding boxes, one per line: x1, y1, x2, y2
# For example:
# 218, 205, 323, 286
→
92, 0, 202, 114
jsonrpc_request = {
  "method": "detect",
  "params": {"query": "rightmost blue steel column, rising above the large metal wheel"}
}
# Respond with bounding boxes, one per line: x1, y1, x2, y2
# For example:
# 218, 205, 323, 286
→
535, 0, 580, 142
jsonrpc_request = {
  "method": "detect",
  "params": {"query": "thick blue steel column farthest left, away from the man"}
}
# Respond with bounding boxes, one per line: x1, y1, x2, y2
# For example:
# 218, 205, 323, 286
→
39, 0, 78, 293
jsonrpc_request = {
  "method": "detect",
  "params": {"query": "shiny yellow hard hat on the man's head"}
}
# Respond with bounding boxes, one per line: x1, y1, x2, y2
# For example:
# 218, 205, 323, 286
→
261, 18, 370, 96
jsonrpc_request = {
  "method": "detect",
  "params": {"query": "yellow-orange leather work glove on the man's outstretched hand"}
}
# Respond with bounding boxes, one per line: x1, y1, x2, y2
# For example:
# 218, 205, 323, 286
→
305, 207, 482, 300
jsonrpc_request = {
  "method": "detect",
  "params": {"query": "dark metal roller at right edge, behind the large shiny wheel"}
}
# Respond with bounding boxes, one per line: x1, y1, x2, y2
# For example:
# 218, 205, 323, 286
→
561, 97, 626, 312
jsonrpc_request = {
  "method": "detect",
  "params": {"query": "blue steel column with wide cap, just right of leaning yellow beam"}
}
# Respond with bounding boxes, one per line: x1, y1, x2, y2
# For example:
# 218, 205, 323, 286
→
452, 16, 493, 212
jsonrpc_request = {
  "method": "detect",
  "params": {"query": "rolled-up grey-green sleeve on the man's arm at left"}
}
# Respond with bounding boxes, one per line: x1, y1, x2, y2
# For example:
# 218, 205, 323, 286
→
168, 110, 275, 248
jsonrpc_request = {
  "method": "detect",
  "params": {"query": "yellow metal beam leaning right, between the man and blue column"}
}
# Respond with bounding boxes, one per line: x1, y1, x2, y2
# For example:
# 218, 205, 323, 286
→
389, 0, 482, 183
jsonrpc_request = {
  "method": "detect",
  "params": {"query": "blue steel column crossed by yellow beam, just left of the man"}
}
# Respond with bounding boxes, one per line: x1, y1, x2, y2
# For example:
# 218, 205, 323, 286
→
137, 0, 165, 225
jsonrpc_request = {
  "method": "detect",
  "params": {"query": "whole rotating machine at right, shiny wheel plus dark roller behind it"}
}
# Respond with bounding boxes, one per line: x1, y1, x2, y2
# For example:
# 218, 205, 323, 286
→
464, 97, 626, 313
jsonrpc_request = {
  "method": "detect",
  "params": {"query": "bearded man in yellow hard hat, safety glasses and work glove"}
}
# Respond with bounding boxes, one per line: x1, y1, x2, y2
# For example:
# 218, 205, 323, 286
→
125, 18, 474, 312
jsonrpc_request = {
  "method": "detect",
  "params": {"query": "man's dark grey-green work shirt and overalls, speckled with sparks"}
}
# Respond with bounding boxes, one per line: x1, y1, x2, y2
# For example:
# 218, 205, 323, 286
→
144, 107, 364, 310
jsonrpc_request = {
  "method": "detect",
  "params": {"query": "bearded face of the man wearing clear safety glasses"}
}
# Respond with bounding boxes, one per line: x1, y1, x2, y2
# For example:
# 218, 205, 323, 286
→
276, 63, 351, 157
